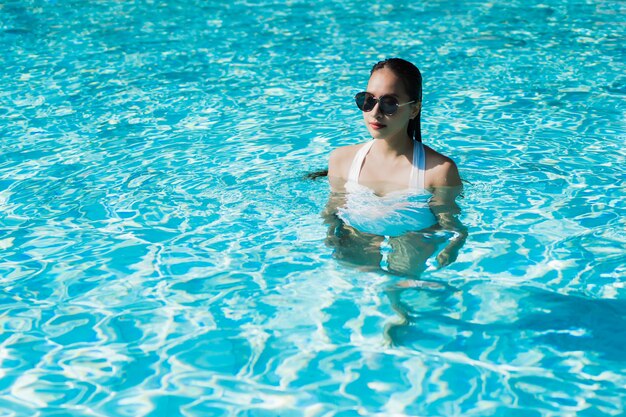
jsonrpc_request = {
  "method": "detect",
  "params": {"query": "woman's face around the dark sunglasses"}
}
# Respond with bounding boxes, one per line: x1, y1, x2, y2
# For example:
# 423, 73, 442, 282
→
363, 68, 421, 139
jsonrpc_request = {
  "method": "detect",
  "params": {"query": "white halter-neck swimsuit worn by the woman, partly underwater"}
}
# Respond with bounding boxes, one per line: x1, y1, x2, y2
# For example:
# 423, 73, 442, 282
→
337, 139, 437, 238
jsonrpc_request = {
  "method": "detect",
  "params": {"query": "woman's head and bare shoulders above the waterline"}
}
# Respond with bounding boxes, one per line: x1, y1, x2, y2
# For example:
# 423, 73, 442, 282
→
328, 58, 461, 194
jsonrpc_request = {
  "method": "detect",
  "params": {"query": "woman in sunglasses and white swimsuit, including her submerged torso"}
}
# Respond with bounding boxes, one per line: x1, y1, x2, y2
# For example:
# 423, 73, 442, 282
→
325, 58, 467, 276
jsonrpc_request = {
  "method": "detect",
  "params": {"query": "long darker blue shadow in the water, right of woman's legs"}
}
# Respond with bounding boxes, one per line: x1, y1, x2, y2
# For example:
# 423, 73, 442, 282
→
378, 282, 626, 364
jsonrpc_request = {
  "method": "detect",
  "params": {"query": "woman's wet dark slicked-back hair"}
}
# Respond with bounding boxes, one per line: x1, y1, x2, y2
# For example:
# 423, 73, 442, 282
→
370, 58, 422, 142
